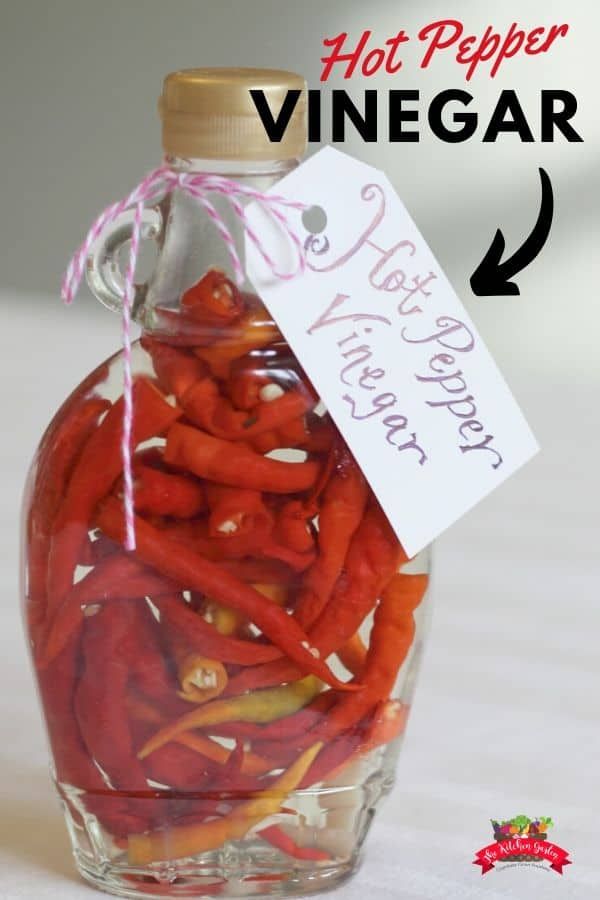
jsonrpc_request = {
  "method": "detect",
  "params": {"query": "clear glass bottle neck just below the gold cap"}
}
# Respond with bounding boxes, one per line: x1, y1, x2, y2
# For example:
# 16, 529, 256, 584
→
137, 156, 299, 332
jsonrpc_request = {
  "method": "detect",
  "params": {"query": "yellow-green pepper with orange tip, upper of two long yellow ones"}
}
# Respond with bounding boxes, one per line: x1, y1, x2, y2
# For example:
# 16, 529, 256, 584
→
138, 675, 323, 759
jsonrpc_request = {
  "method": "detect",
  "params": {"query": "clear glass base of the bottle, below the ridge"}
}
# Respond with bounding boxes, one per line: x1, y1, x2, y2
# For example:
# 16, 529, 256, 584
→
59, 771, 393, 900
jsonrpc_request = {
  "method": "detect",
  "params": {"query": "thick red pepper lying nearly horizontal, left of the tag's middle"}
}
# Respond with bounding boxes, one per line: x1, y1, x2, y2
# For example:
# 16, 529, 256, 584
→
165, 425, 319, 494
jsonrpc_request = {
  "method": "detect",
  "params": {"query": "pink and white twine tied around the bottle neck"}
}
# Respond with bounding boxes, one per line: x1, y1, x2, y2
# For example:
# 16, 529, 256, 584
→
61, 166, 306, 550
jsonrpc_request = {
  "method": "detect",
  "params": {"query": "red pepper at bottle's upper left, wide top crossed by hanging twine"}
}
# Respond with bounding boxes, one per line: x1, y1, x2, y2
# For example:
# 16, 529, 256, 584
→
48, 378, 180, 614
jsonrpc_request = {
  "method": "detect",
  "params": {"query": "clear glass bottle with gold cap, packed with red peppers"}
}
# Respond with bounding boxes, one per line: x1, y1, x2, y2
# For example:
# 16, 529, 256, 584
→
23, 69, 428, 897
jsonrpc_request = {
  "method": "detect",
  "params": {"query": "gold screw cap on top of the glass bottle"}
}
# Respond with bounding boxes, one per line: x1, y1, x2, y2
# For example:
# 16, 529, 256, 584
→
158, 68, 307, 161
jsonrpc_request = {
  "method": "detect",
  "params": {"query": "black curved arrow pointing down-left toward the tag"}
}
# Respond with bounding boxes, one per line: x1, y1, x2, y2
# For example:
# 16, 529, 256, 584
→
471, 169, 554, 297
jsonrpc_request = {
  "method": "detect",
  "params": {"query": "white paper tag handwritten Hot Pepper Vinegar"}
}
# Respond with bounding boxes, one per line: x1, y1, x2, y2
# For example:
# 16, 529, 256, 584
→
246, 147, 538, 556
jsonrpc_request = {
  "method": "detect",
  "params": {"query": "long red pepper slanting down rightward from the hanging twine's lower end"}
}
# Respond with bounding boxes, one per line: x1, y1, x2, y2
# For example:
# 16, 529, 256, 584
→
97, 500, 356, 690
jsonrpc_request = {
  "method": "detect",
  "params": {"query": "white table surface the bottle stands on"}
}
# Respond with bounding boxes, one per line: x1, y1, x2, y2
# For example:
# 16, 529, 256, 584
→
0, 293, 600, 900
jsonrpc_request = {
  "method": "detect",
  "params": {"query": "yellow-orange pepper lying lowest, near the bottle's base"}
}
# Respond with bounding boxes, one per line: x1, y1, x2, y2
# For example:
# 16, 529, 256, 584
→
128, 744, 323, 866
